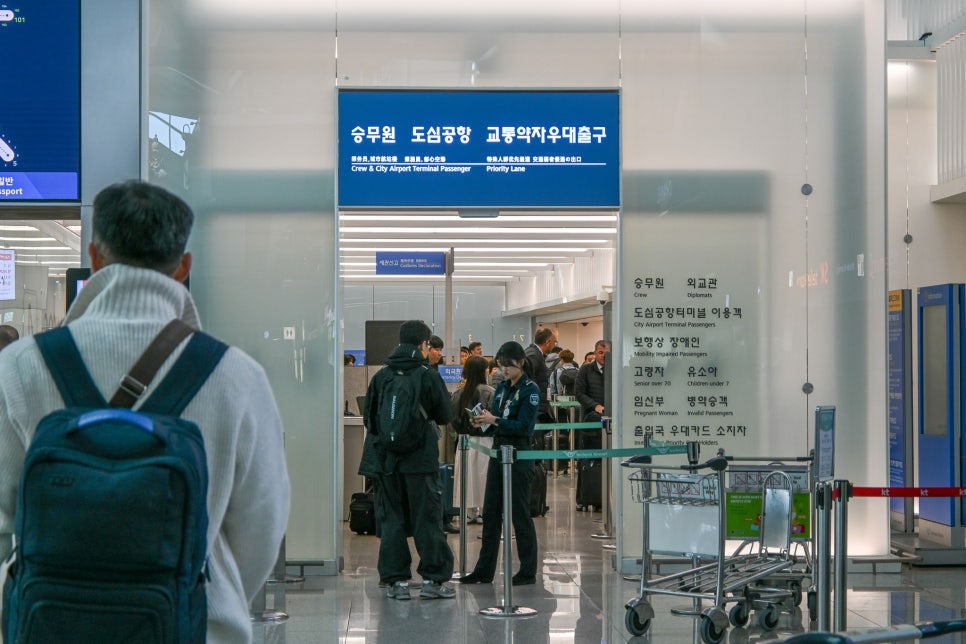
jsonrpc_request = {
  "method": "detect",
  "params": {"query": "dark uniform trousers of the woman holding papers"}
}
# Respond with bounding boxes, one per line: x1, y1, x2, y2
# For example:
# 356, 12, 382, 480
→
473, 458, 537, 582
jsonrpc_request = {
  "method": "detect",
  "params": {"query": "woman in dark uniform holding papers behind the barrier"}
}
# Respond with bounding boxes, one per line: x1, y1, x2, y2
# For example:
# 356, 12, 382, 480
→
459, 341, 540, 586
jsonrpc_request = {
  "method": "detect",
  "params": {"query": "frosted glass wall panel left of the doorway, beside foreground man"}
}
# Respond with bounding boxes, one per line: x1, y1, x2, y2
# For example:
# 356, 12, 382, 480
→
143, 0, 342, 574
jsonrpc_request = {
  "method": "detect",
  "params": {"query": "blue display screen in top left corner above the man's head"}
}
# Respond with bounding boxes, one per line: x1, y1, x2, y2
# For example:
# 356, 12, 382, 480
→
0, 0, 80, 201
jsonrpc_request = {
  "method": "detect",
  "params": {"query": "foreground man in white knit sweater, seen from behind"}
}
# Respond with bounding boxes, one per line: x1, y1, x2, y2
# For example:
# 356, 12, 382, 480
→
0, 181, 290, 643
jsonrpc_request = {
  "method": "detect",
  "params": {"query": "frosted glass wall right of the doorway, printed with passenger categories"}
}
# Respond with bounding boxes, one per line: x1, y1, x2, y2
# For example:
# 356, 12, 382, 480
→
615, 1, 888, 567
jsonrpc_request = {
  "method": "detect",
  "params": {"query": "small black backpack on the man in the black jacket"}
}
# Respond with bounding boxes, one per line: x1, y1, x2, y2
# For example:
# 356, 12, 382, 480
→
376, 367, 428, 454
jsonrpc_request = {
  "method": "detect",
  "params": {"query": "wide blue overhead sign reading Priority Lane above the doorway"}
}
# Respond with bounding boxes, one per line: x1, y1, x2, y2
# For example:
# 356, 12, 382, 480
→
338, 89, 620, 208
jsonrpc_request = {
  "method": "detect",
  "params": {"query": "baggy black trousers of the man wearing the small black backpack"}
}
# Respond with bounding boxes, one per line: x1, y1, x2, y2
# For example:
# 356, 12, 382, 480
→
375, 472, 453, 583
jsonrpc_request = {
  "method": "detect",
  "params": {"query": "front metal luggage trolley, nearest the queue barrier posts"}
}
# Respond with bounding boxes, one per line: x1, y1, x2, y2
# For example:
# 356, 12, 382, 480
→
622, 456, 794, 644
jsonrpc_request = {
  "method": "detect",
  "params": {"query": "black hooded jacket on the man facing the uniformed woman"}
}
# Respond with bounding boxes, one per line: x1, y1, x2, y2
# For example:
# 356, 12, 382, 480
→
359, 344, 453, 476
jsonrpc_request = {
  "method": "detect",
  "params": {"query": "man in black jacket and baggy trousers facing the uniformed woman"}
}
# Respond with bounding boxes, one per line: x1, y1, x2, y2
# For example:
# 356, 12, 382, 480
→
360, 320, 455, 600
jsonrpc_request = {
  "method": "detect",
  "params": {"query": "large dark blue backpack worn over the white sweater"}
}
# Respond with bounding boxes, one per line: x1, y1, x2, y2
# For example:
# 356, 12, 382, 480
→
3, 322, 228, 644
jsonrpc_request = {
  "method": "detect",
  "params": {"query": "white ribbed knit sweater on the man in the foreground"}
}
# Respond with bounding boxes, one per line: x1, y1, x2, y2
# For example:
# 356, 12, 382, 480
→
0, 264, 289, 644
